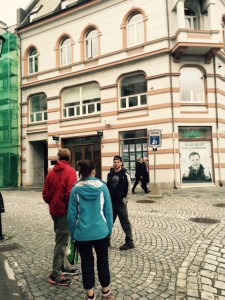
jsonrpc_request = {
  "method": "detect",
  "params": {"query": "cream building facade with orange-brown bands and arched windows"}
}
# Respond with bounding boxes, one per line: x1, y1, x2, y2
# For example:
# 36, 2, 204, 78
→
17, 0, 225, 187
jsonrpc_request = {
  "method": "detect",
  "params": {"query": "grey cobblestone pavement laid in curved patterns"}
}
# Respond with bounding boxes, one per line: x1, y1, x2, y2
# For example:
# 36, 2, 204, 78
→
0, 187, 225, 300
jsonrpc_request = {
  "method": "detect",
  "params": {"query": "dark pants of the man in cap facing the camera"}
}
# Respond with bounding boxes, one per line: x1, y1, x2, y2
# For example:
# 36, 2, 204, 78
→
112, 201, 134, 246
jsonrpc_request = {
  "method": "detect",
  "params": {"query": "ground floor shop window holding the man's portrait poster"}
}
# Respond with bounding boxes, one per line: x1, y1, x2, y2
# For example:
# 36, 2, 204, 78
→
179, 127, 213, 184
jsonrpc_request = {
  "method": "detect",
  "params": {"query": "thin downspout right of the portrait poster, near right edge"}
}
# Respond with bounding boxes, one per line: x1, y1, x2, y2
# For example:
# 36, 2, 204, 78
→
213, 55, 223, 187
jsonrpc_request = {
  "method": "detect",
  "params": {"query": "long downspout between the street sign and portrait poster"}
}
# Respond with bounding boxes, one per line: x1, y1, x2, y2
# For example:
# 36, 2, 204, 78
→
166, 0, 177, 189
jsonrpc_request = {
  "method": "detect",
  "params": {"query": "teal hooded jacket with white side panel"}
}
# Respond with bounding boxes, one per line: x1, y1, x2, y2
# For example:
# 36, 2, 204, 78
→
67, 177, 113, 241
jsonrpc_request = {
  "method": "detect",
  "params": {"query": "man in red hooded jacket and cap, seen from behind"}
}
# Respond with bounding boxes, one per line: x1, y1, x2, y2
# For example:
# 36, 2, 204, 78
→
42, 148, 79, 286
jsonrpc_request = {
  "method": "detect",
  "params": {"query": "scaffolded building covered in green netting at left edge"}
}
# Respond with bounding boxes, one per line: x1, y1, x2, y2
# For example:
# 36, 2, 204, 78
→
0, 32, 19, 188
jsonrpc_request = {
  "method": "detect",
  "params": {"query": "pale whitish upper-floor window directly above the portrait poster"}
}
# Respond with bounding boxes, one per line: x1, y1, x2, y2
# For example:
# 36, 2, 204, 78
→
180, 68, 205, 103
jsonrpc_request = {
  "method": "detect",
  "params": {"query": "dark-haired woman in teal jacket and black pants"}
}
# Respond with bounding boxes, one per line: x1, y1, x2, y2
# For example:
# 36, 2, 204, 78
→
68, 160, 115, 300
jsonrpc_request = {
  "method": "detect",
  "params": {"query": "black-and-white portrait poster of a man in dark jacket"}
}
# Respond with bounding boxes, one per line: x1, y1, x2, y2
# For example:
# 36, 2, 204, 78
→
180, 141, 213, 183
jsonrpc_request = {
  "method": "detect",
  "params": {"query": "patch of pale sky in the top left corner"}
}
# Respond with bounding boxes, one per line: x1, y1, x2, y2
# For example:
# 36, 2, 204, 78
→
0, 0, 32, 27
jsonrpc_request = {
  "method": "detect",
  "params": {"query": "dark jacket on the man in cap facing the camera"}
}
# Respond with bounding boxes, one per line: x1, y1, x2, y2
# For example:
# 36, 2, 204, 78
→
107, 168, 129, 202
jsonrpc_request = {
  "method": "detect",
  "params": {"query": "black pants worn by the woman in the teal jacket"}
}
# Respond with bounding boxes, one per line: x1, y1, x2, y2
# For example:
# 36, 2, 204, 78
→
76, 237, 110, 290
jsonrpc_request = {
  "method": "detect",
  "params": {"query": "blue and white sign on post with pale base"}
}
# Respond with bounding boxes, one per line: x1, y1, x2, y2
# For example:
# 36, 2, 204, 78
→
149, 129, 162, 198
